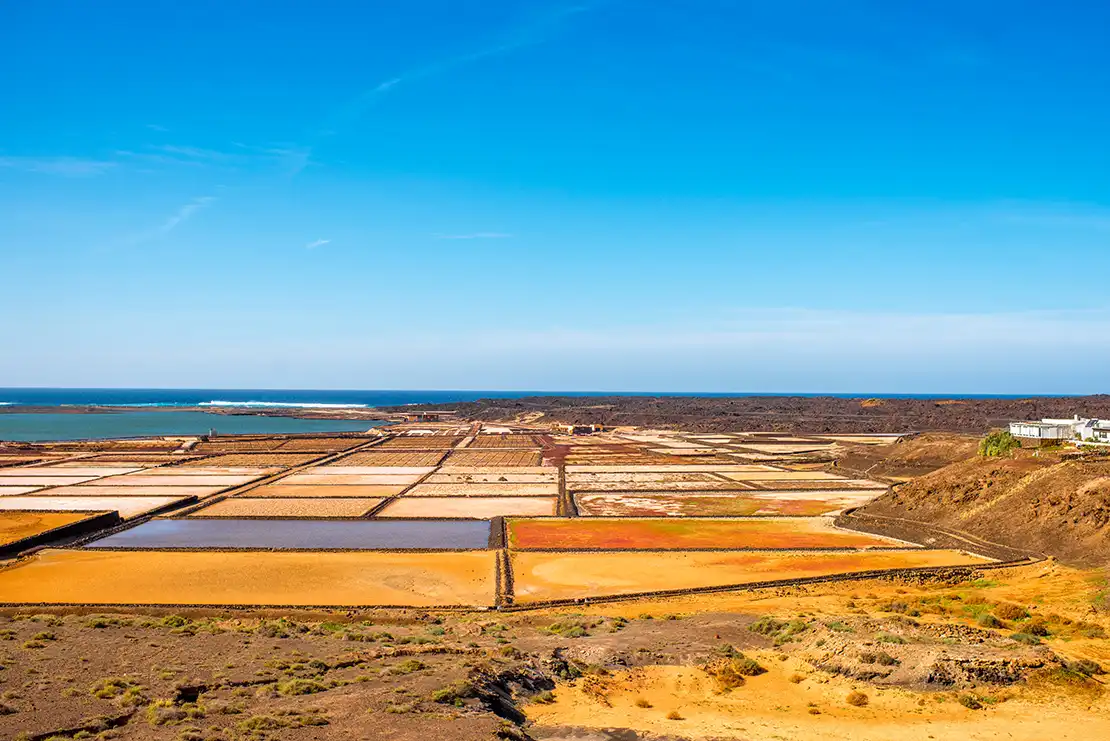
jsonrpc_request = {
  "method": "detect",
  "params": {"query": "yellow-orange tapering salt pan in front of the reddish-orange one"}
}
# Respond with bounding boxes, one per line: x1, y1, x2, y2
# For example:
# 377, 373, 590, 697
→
512, 550, 987, 602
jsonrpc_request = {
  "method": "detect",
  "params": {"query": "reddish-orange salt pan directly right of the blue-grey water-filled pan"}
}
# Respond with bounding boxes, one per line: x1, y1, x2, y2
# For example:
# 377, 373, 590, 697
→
508, 517, 906, 550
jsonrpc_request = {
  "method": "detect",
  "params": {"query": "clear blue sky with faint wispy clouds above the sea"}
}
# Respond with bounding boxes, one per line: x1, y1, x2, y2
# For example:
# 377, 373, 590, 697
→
0, 0, 1110, 393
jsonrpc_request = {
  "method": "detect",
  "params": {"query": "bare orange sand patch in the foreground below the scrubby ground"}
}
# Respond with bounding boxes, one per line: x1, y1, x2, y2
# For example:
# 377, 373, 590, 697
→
527, 653, 1110, 741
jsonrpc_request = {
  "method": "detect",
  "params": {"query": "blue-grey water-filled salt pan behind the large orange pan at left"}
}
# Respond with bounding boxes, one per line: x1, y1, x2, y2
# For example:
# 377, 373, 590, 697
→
93, 519, 490, 550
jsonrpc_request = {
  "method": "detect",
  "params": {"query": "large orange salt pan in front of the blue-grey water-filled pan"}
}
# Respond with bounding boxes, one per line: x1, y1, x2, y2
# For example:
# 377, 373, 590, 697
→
0, 549, 495, 607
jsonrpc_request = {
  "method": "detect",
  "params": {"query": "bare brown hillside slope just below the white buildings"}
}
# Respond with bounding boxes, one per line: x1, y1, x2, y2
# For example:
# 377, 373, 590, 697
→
862, 451, 1110, 566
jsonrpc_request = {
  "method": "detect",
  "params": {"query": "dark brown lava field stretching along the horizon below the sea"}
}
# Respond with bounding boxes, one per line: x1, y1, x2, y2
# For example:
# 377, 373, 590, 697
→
381, 395, 1110, 434
